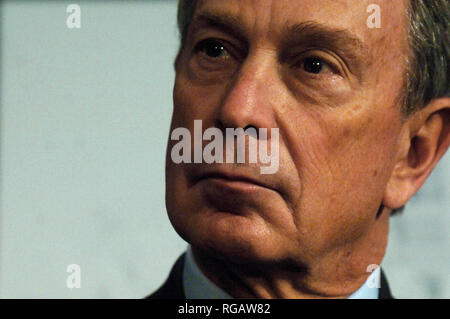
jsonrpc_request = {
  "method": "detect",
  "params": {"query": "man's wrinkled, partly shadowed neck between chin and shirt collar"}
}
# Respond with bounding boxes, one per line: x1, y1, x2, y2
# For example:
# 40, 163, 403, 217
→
192, 214, 389, 299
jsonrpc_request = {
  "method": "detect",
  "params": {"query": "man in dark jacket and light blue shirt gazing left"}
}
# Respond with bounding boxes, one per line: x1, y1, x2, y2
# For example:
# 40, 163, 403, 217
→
150, 0, 450, 298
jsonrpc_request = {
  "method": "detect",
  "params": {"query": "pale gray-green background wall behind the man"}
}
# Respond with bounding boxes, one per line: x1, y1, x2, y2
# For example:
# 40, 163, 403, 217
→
0, 0, 450, 298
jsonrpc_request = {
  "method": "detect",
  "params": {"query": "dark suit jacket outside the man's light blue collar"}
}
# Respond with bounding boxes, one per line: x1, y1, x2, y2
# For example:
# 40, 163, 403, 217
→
145, 254, 394, 299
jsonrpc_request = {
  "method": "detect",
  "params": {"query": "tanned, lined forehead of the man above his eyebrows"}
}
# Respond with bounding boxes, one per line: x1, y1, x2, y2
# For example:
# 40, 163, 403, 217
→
194, 0, 408, 52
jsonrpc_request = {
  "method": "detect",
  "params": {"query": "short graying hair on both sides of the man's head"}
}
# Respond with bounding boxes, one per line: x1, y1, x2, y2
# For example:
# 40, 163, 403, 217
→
178, 0, 450, 116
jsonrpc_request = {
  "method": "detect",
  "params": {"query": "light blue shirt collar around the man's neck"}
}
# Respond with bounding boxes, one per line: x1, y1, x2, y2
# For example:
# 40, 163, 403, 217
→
183, 246, 380, 299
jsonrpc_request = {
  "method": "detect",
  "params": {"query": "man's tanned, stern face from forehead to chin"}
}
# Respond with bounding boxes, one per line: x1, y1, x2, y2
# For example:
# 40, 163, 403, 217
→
166, 0, 407, 266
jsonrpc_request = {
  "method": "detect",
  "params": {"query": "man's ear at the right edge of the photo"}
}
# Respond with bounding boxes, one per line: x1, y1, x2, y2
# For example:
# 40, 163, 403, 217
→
383, 98, 450, 209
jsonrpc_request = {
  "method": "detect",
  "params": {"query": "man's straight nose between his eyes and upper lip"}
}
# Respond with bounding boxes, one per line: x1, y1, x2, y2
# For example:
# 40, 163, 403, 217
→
216, 54, 280, 135
